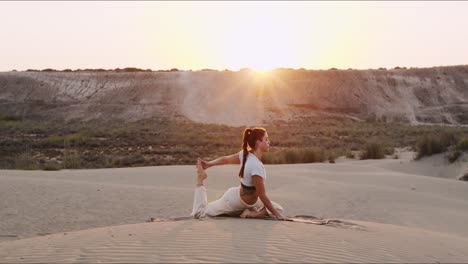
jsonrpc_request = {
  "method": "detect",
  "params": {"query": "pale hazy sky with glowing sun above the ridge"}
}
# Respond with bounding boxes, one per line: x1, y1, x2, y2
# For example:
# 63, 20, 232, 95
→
0, 1, 468, 71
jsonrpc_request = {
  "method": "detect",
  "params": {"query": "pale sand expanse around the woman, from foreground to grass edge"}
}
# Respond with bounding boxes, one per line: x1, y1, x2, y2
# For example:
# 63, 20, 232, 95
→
0, 155, 468, 263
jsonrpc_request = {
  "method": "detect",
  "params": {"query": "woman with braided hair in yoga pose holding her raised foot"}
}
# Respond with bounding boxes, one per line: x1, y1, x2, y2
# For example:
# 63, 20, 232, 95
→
191, 128, 289, 220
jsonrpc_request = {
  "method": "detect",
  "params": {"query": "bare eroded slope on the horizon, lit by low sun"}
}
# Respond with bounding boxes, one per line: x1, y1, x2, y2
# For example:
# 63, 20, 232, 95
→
0, 66, 468, 126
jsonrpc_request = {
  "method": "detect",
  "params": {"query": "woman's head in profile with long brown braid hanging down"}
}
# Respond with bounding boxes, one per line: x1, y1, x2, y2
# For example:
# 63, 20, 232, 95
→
239, 127, 270, 178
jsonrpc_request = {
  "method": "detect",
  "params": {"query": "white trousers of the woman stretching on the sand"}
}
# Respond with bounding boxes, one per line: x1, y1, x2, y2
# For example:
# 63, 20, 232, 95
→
191, 186, 283, 218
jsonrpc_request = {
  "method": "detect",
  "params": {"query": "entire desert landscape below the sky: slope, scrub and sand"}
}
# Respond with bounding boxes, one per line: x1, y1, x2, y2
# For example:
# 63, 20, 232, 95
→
0, 65, 468, 263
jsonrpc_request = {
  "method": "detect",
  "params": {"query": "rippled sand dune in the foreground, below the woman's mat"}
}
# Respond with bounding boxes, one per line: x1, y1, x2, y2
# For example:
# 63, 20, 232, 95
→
0, 219, 468, 263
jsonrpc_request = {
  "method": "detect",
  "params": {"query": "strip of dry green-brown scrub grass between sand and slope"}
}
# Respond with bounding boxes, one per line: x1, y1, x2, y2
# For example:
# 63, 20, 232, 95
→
0, 115, 468, 169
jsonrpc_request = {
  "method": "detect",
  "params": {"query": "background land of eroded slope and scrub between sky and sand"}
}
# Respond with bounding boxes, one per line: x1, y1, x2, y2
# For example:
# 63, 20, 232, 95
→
0, 68, 468, 170
